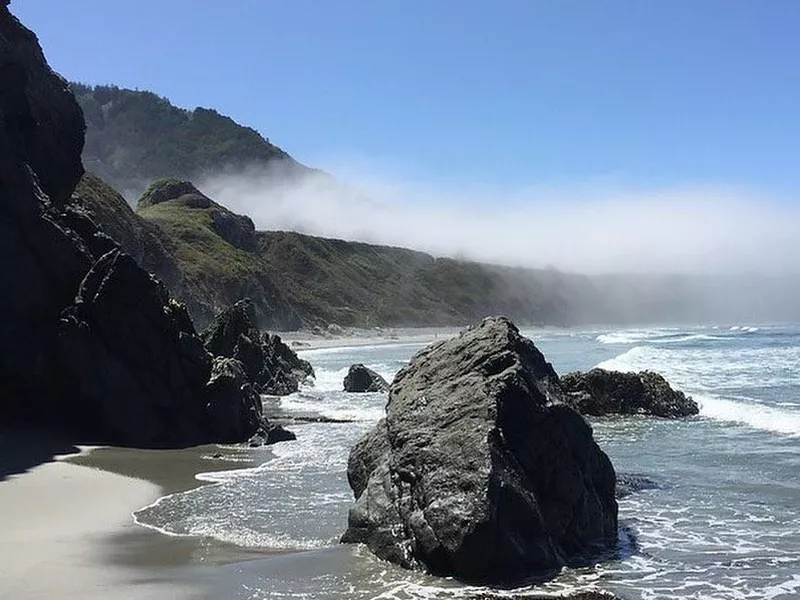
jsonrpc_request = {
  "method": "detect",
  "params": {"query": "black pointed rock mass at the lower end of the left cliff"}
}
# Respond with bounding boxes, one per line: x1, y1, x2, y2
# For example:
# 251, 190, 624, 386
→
55, 249, 265, 447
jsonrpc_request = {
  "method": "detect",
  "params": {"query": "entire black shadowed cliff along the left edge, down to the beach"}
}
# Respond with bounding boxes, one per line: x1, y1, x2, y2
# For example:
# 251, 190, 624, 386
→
0, 4, 263, 446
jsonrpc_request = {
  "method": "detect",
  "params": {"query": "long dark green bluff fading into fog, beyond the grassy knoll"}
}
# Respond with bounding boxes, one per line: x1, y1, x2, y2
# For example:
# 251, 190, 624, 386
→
258, 232, 593, 326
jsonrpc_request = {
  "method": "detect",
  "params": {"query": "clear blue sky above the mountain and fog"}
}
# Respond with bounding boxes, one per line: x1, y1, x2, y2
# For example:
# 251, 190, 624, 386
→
11, 0, 800, 194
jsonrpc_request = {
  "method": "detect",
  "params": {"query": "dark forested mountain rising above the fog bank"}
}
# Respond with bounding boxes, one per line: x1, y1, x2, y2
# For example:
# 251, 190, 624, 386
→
70, 83, 310, 200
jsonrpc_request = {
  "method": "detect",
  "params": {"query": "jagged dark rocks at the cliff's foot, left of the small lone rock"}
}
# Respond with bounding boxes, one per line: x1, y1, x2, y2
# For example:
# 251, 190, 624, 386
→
203, 298, 314, 396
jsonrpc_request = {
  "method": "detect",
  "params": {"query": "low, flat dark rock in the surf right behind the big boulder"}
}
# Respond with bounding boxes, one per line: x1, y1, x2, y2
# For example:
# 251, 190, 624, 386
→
561, 369, 699, 418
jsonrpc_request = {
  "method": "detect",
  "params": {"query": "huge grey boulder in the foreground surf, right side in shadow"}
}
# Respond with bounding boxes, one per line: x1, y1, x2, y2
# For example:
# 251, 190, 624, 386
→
342, 317, 617, 582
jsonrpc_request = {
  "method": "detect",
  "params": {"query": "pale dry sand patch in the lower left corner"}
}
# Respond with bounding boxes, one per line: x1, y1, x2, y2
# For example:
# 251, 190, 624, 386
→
0, 442, 199, 600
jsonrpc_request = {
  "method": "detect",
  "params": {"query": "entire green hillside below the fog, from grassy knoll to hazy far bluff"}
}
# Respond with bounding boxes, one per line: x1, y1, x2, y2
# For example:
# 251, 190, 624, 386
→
76, 174, 601, 329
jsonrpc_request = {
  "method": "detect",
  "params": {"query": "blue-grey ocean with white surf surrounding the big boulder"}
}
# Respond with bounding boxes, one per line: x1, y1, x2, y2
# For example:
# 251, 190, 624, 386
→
135, 324, 800, 600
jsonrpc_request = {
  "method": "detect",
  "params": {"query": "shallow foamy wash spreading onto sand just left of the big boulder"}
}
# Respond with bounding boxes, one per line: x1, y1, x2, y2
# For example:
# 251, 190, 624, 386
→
134, 423, 368, 550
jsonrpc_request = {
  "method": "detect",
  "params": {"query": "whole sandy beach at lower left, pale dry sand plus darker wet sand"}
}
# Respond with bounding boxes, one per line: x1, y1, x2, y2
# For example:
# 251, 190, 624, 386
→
0, 432, 276, 600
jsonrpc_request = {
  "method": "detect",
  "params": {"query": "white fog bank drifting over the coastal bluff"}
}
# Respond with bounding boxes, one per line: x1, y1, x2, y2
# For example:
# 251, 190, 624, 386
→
197, 166, 800, 276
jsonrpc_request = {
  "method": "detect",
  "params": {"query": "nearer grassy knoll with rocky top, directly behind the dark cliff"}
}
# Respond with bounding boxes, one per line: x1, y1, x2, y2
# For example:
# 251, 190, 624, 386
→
74, 173, 301, 330
